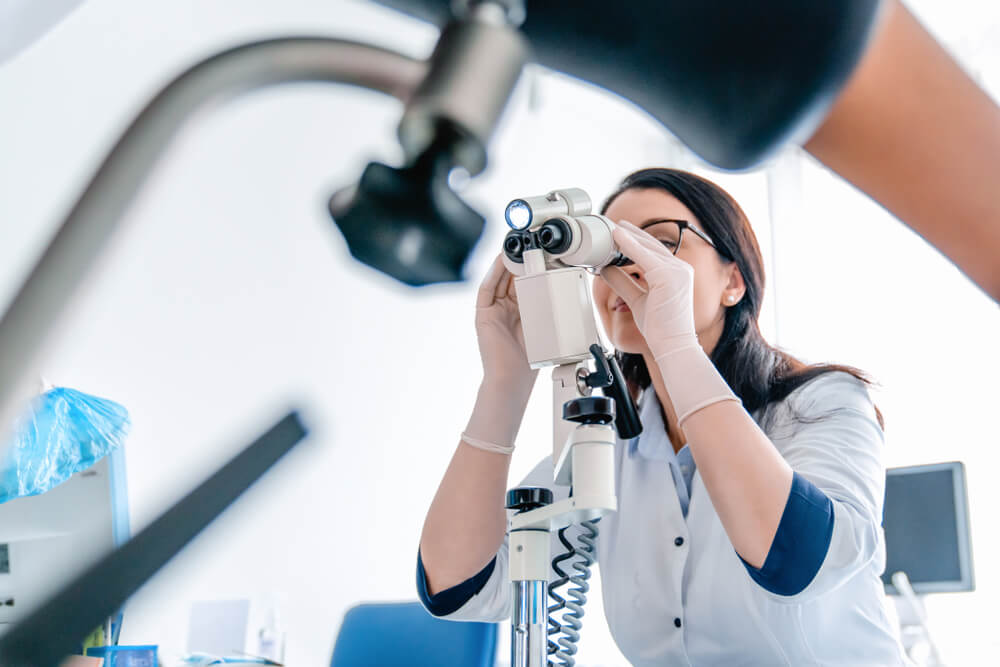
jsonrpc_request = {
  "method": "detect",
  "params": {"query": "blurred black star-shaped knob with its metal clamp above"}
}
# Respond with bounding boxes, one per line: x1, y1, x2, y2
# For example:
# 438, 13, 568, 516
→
329, 2, 528, 287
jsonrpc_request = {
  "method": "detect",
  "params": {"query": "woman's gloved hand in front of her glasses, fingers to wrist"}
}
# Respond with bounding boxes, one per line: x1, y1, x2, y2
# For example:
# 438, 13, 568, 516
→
601, 220, 698, 360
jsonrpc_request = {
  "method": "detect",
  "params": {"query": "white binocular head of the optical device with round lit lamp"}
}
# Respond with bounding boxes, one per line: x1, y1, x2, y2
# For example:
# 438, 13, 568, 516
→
503, 188, 631, 271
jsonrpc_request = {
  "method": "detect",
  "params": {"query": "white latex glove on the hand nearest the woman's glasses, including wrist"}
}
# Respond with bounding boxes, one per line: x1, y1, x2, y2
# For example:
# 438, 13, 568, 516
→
601, 220, 739, 424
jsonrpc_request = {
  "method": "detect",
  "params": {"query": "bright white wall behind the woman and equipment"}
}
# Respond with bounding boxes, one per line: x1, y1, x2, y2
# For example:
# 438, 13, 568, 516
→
0, 0, 1000, 665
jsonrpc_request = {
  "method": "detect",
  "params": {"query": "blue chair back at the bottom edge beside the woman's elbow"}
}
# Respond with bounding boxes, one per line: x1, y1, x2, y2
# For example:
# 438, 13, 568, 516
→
330, 602, 497, 667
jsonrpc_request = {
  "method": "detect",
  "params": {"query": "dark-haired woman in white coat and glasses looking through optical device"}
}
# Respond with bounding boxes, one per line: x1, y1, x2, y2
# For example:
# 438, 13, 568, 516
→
418, 169, 907, 666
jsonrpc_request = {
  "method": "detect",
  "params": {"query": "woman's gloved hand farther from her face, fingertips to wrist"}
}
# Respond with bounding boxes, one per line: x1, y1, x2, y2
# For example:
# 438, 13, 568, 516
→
476, 253, 538, 386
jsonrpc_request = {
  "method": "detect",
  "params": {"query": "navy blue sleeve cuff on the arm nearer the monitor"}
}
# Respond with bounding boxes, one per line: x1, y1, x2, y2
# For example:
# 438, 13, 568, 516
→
737, 472, 833, 595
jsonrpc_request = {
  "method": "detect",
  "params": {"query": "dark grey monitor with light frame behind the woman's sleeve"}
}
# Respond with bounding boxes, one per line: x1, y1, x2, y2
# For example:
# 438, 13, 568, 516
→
882, 462, 974, 594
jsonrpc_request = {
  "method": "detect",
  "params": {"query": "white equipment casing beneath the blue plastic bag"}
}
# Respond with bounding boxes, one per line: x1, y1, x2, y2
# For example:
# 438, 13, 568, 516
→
0, 448, 129, 635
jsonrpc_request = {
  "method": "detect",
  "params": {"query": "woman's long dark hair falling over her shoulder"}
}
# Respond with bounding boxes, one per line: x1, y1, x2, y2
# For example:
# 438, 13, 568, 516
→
601, 168, 883, 426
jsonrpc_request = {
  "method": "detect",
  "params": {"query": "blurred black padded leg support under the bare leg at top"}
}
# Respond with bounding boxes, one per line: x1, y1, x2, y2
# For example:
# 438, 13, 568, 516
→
377, 0, 882, 169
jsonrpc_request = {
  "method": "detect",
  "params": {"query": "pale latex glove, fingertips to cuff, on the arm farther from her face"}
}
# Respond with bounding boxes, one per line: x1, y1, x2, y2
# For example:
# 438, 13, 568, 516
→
462, 255, 538, 454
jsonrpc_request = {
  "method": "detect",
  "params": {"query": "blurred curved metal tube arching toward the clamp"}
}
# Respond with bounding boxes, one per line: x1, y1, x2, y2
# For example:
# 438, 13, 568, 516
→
0, 37, 428, 434
